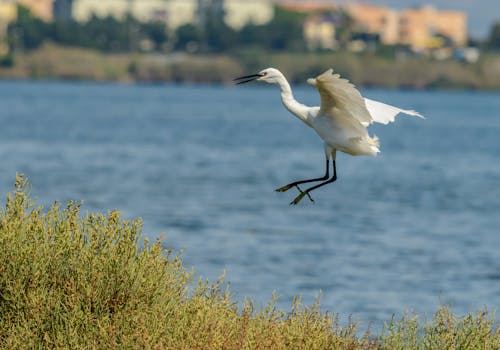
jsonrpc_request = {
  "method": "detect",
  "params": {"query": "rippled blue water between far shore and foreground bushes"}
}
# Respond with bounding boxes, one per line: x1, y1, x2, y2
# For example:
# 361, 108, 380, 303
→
0, 81, 500, 328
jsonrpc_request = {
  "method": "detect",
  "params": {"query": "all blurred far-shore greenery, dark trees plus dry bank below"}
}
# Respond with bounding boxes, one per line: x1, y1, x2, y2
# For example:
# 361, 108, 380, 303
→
0, 7, 500, 89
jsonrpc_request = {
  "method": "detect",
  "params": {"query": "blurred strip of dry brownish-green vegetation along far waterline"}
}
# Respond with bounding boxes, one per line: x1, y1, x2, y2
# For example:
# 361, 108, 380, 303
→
0, 43, 500, 89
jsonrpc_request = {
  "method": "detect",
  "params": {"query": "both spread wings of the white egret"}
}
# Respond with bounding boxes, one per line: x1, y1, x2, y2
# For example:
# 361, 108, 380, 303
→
307, 69, 424, 126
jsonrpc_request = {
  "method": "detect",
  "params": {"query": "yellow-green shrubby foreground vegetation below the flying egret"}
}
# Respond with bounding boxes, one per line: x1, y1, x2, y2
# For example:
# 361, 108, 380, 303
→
0, 176, 500, 349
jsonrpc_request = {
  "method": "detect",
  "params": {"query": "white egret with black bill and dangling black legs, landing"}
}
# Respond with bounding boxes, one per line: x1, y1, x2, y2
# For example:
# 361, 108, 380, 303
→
234, 68, 424, 205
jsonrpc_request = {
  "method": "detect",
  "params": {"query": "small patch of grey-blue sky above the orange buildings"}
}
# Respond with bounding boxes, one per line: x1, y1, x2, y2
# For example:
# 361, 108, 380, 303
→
346, 0, 500, 39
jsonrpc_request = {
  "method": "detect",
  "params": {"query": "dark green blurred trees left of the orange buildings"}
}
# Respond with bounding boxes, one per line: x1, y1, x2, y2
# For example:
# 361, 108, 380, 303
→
8, 7, 306, 52
